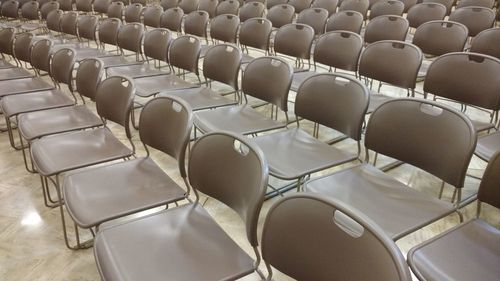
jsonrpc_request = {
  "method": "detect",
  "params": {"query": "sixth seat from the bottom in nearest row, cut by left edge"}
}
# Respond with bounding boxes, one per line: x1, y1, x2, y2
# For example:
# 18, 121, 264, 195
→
0, 77, 54, 97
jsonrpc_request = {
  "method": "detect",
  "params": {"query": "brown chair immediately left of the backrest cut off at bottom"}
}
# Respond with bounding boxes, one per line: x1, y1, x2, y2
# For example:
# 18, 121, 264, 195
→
94, 133, 268, 280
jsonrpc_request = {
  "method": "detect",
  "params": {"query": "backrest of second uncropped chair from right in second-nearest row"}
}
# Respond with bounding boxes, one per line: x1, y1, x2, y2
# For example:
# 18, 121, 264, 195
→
295, 73, 370, 141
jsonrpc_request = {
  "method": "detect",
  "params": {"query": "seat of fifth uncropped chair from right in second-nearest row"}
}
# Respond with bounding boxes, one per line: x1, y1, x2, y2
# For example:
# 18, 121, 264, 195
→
134, 74, 197, 97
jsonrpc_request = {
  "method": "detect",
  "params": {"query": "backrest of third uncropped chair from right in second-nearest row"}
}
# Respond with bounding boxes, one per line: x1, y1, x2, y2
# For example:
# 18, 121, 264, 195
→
241, 57, 293, 112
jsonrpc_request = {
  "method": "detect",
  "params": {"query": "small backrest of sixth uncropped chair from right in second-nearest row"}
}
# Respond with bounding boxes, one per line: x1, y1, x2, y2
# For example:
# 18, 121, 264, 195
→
143, 28, 172, 62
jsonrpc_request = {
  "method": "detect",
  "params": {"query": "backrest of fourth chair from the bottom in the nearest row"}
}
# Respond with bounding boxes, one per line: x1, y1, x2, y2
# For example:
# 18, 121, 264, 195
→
95, 76, 135, 139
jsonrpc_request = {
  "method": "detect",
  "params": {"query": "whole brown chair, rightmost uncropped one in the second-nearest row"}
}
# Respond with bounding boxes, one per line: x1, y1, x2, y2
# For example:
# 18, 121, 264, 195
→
305, 99, 476, 240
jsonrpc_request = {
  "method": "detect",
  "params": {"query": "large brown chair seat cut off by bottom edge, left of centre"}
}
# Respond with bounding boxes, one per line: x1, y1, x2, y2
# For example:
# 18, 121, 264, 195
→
94, 204, 253, 281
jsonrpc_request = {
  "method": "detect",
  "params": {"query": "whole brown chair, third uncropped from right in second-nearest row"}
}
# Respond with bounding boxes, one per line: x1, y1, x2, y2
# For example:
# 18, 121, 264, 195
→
194, 57, 293, 135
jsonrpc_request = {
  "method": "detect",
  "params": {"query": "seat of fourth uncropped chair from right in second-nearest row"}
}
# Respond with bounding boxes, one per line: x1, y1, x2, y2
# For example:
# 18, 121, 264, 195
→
160, 87, 238, 111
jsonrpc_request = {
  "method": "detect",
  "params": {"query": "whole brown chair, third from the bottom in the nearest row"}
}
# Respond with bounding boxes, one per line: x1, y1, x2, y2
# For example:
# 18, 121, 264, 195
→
62, 97, 192, 249
